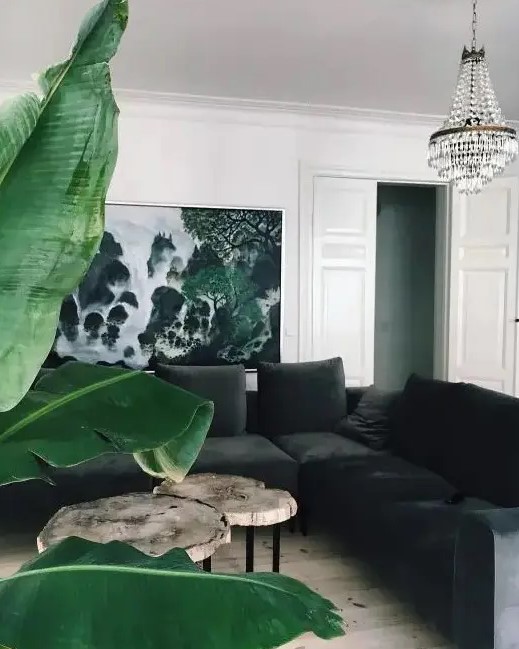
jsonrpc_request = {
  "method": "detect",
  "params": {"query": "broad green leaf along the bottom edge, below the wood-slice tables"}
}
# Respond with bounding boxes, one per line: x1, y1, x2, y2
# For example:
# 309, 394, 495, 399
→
0, 538, 343, 649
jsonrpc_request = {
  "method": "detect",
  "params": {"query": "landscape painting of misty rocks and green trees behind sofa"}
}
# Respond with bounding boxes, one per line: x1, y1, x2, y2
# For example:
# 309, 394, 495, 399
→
52, 204, 283, 369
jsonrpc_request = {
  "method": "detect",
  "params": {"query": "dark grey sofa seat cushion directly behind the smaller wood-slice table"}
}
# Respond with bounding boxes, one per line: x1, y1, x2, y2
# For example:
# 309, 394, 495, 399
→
191, 435, 298, 495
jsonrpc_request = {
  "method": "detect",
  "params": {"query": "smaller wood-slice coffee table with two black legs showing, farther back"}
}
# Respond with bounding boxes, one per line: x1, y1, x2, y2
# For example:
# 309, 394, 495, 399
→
154, 473, 297, 572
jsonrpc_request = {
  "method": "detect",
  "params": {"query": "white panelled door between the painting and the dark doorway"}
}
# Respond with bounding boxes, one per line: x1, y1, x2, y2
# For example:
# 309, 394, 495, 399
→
306, 176, 377, 386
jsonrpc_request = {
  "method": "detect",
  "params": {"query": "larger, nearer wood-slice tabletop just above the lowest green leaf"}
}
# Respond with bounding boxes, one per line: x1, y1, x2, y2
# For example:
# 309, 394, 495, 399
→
37, 493, 231, 562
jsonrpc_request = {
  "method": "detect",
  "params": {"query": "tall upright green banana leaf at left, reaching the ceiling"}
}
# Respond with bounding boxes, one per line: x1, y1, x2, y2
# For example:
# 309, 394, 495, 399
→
0, 0, 128, 411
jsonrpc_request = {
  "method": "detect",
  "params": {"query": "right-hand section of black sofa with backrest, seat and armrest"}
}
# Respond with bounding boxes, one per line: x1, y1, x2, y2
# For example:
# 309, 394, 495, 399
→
312, 376, 519, 649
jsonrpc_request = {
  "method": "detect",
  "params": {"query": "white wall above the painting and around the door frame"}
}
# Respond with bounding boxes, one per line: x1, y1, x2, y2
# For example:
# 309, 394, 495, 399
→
4, 90, 517, 361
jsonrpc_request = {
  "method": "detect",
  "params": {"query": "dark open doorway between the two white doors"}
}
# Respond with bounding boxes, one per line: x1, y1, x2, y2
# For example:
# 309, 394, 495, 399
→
374, 183, 438, 390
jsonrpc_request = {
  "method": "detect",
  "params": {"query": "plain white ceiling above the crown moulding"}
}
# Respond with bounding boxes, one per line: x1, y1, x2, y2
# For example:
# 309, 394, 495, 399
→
0, 0, 519, 119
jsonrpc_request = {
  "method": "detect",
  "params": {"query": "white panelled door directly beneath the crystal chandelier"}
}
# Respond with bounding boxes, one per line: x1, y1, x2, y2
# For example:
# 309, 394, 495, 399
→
448, 178, 519, 394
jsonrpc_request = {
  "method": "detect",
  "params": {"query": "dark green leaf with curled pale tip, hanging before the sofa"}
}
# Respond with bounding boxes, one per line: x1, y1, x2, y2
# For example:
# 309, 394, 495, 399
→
0, 362, 214, 485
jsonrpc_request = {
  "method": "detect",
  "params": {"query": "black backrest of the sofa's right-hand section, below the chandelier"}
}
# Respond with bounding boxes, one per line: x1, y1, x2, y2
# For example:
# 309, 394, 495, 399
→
392, 376, 519, 507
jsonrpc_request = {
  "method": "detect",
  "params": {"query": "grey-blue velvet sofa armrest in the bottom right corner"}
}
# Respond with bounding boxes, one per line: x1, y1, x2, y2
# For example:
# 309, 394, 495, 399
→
453, 508, 519, 649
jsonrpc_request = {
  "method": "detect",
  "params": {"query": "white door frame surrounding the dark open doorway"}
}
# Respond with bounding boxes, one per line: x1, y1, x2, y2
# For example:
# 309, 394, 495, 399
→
298, 161, 451, 379
